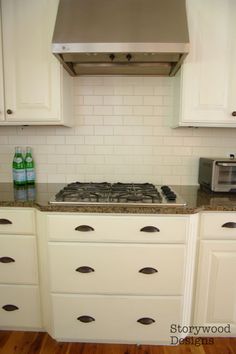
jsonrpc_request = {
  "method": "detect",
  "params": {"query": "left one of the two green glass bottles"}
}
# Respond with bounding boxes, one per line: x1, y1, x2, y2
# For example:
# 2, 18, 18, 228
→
12, 146, 26, 186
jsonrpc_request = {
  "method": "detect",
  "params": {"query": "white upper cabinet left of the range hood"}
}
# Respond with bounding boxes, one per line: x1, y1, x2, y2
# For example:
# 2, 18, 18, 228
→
0, 0, 73, 126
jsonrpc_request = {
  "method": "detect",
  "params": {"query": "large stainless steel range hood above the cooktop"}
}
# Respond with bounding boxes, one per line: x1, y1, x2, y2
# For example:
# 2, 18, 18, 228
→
52, 0, 189, 76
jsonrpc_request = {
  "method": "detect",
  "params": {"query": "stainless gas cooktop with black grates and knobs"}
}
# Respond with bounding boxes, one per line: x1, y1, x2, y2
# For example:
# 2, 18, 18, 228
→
50, 182, 186, 206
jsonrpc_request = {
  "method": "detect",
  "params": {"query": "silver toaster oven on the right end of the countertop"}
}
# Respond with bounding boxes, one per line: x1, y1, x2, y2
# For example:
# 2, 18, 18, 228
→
198, 157, 236, 192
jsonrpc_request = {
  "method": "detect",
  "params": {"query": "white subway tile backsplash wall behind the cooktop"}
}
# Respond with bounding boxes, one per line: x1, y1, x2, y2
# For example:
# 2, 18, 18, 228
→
0, 77, 236, 184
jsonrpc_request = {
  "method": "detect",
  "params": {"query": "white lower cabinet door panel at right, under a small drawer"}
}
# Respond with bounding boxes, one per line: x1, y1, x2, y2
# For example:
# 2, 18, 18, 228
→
195, 241, 236, 335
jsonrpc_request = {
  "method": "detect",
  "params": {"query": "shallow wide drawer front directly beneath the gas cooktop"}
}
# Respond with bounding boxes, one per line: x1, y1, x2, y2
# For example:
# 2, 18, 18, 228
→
48, 214, 188, 243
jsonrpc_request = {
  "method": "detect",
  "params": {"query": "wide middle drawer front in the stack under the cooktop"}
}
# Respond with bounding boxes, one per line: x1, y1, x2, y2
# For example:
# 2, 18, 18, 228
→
49, 243, 185, 295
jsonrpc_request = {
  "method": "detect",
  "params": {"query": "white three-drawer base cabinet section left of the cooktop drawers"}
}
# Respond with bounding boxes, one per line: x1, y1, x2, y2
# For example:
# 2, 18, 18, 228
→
0, 208, 41, 330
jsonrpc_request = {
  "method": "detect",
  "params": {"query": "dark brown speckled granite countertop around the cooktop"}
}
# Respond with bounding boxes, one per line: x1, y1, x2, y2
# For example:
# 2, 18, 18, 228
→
0, 183, 236, 214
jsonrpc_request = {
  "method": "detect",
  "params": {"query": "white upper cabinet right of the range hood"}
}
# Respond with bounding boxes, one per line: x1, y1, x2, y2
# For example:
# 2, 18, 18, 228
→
174, 0, 236, 127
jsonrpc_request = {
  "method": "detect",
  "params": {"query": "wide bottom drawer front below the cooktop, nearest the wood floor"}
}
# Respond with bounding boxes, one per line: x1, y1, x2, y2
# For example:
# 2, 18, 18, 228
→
52, 294, 181, 344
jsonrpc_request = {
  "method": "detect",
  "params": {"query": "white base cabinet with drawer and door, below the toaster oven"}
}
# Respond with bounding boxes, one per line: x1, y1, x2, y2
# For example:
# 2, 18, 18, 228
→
194, 213, 236, 337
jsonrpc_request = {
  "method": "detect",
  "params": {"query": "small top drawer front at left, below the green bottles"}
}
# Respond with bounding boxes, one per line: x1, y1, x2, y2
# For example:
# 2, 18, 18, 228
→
0, 209, 35, 235
